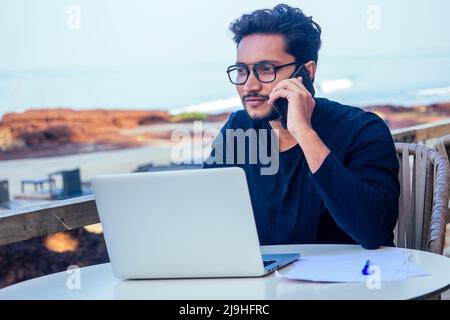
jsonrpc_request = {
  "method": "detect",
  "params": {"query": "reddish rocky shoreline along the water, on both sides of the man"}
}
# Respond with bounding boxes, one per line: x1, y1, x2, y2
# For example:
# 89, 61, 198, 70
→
0, 102, 450, 162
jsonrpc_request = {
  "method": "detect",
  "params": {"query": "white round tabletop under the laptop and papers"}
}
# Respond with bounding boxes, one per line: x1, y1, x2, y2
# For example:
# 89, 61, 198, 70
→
0, 245, 450, 300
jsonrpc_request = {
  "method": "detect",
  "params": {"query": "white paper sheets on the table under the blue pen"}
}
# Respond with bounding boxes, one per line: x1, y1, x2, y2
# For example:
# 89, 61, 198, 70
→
283, 250, 429, 282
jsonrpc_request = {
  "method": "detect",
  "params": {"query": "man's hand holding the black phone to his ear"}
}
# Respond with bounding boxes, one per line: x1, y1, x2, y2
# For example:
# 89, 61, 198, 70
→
268, 77, 316, 141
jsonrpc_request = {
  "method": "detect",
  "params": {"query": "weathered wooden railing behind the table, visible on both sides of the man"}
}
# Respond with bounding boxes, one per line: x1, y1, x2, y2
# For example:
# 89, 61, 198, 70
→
0, 119, 450, 245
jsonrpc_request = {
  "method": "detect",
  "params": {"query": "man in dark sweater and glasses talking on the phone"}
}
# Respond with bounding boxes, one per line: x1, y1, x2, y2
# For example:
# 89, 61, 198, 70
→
204, 4, 400, 249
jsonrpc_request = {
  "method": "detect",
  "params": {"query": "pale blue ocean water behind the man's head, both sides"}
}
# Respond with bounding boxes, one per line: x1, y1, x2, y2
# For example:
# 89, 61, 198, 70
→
0, 54, 450, 116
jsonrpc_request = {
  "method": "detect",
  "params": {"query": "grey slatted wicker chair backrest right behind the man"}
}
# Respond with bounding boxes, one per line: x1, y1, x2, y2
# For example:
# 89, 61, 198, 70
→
395, 143, 450, 254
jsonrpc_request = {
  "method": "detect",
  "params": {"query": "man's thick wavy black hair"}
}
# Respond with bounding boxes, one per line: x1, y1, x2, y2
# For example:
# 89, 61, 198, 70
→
229, 4, 322, 63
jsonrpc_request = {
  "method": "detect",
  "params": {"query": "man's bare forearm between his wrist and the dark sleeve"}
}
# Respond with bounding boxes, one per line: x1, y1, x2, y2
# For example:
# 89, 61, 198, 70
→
294, 129, 330, 173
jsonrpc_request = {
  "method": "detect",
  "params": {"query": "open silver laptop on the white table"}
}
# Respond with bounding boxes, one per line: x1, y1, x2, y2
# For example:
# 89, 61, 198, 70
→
93, 168, 299, 279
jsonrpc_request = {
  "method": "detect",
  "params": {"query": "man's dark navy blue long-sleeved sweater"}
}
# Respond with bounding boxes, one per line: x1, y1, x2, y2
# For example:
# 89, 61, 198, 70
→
204, 98, 400, 249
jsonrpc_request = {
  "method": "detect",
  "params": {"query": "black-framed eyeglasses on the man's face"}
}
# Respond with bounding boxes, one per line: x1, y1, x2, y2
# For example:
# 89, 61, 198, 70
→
227, 61, 301, 86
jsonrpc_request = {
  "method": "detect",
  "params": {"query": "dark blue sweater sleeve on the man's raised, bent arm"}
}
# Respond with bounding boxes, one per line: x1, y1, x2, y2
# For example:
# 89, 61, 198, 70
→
310, 118, 400, 249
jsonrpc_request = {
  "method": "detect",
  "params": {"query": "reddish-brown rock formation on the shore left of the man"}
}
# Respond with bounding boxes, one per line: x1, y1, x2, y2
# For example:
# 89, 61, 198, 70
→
0, 109, 170, 160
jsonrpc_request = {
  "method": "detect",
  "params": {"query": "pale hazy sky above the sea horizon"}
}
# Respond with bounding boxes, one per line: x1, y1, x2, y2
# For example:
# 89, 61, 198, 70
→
0, 0, 450, 70
